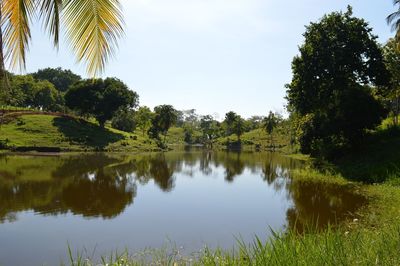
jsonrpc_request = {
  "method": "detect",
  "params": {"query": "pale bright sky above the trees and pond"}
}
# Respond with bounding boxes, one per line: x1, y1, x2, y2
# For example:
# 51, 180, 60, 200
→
26, 0, 396, 118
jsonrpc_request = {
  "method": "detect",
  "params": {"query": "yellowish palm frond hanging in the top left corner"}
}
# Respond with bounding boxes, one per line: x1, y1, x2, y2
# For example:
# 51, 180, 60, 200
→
2, 0, 35, 70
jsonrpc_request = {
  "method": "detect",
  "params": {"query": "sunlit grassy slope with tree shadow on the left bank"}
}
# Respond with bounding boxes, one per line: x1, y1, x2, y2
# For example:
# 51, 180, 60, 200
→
0, 115, 157, 151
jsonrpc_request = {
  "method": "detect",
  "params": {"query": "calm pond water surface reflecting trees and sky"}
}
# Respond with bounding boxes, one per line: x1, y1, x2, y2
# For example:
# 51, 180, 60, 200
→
0, 151, 364, 265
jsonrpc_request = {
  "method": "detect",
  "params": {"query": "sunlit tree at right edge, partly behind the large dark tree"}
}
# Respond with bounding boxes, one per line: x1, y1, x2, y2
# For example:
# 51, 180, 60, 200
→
383, 39, 400, 125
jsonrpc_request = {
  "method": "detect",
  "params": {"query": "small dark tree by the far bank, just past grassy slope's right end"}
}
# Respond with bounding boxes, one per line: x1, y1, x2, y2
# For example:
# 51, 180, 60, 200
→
149, 105, 177, 143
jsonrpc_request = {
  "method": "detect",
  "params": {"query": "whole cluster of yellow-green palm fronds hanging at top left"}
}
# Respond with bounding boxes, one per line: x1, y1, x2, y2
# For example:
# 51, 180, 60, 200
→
0, 0, 123, 97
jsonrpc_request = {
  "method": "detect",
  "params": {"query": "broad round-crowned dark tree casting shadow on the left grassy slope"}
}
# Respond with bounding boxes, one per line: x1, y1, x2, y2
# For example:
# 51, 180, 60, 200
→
65, 78, 139, 127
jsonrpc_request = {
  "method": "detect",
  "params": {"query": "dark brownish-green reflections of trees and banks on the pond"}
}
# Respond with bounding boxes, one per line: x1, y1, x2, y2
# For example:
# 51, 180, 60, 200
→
0, 150, 364, 230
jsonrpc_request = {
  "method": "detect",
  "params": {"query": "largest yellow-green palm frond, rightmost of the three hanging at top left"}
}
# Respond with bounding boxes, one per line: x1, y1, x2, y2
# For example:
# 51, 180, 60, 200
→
63, 0, 123, 77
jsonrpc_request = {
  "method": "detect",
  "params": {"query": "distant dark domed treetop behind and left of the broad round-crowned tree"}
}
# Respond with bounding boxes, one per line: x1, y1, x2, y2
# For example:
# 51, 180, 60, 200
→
32, 67, 81, 92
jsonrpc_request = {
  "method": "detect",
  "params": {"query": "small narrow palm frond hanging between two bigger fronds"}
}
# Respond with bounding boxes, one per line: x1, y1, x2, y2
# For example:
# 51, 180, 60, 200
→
39, 0, 63, 48
